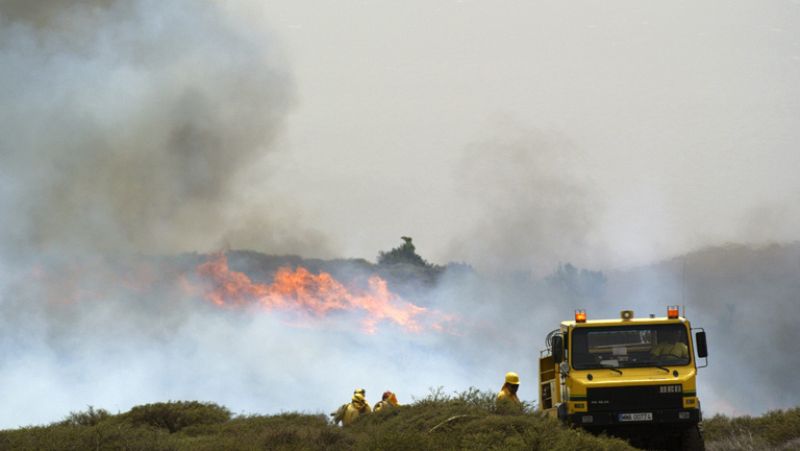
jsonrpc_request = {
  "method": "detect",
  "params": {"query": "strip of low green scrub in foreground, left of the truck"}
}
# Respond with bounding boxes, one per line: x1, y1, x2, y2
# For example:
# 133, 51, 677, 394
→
0, 389, 633, 450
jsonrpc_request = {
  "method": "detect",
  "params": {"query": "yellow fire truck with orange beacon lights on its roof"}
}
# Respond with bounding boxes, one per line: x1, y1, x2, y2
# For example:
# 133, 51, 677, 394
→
539, 306, 708, 450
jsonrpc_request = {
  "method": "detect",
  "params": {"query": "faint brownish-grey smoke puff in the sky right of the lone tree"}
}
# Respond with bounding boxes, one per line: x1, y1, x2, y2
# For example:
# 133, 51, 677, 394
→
448, 124, 602, 275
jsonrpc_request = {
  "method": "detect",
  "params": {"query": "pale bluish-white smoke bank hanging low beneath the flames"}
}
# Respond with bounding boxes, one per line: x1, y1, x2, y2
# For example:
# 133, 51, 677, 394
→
0, 254, 480, 427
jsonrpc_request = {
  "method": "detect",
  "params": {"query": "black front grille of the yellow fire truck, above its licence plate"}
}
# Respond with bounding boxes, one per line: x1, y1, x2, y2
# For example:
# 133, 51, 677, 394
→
586, 385, 683, 412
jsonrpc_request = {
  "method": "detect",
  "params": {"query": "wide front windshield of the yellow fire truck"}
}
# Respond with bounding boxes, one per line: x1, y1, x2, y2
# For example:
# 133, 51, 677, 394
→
571, 324, 689, 370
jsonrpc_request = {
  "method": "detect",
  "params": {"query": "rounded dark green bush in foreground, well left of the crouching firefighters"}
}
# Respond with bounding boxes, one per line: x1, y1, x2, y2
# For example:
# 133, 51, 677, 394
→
125, 401, 231, 433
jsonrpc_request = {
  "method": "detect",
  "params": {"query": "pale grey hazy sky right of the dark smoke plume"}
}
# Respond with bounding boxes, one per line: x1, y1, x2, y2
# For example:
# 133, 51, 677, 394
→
233, 1, 800, 267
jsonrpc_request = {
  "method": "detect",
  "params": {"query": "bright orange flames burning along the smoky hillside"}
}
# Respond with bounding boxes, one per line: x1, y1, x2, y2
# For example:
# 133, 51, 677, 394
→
192, 253, 432, 333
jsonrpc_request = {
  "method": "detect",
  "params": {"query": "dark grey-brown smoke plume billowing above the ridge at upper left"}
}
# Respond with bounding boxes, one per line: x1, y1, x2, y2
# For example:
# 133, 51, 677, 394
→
0, 0, 332, 254
